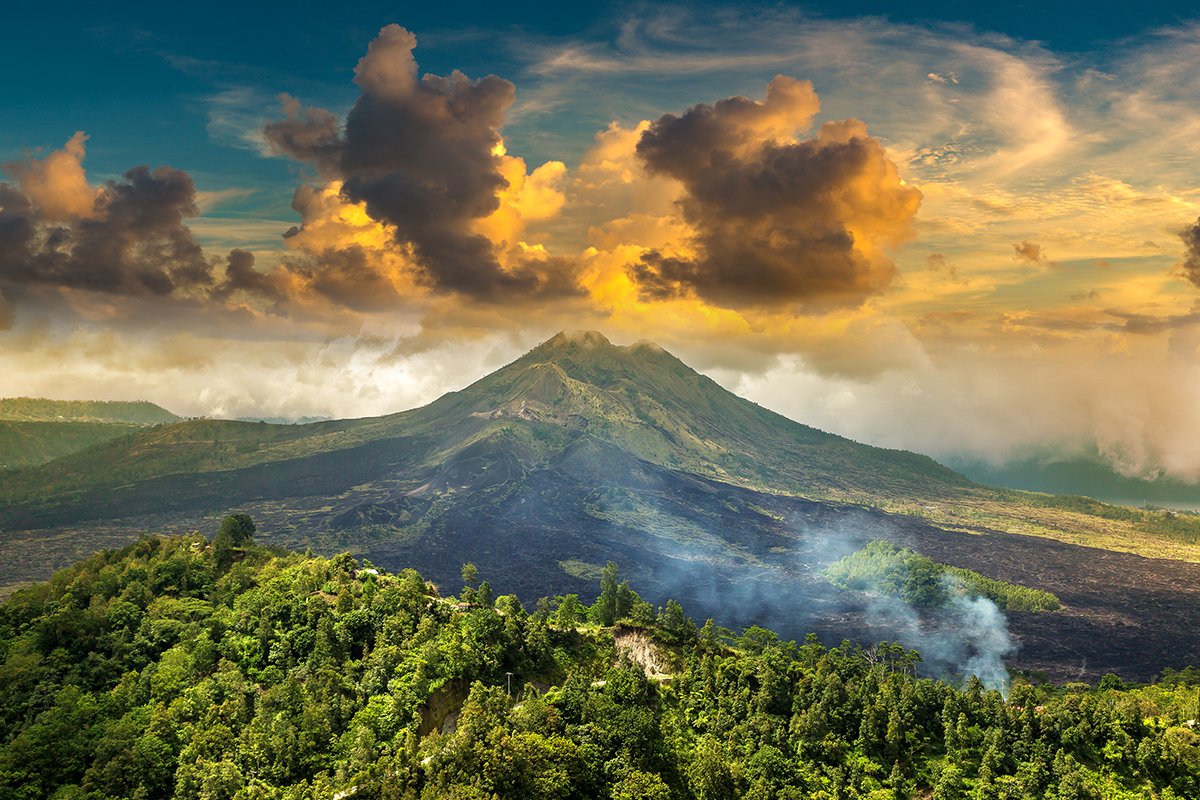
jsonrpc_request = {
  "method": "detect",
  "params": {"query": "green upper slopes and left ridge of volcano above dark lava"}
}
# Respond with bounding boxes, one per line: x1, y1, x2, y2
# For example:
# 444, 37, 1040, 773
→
0, 331, 971, 503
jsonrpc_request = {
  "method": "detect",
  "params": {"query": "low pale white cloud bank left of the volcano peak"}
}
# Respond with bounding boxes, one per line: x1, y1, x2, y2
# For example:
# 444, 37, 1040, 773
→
0, 325, 536, 419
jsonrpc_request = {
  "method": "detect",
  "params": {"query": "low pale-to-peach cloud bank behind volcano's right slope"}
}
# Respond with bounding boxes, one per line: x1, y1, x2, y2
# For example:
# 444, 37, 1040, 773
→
714, 320, 1200, 482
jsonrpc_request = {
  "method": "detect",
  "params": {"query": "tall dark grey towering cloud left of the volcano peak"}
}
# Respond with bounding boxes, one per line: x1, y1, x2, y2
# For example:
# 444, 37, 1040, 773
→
264, 25, 577, 300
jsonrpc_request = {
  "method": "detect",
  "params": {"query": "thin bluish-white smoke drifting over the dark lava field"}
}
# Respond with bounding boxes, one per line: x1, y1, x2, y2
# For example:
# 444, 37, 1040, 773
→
575, 469, 1015, 693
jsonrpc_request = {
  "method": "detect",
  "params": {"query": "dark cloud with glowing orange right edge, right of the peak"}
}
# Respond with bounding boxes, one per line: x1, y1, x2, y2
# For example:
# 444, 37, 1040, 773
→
631, 76, 922, 309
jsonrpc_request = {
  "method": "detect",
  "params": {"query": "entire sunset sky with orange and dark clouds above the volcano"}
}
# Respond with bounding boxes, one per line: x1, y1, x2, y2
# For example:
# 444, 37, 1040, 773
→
0, 1, 1200, 482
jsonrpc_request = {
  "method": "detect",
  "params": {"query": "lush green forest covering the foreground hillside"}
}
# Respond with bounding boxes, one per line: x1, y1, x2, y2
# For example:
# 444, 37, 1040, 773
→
0, 515, 1200, 800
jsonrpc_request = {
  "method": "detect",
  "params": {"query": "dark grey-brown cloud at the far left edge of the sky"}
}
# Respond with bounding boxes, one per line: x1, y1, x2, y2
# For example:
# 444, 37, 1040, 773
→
0, 167, 212, 295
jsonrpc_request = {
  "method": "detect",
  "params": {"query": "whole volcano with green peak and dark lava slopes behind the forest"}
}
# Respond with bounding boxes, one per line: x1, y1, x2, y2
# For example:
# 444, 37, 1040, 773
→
0, 332, 1200, 679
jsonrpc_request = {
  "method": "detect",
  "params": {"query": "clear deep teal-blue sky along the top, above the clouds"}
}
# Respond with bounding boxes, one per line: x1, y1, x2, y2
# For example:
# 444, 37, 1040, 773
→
7, 0, 1195, 194
